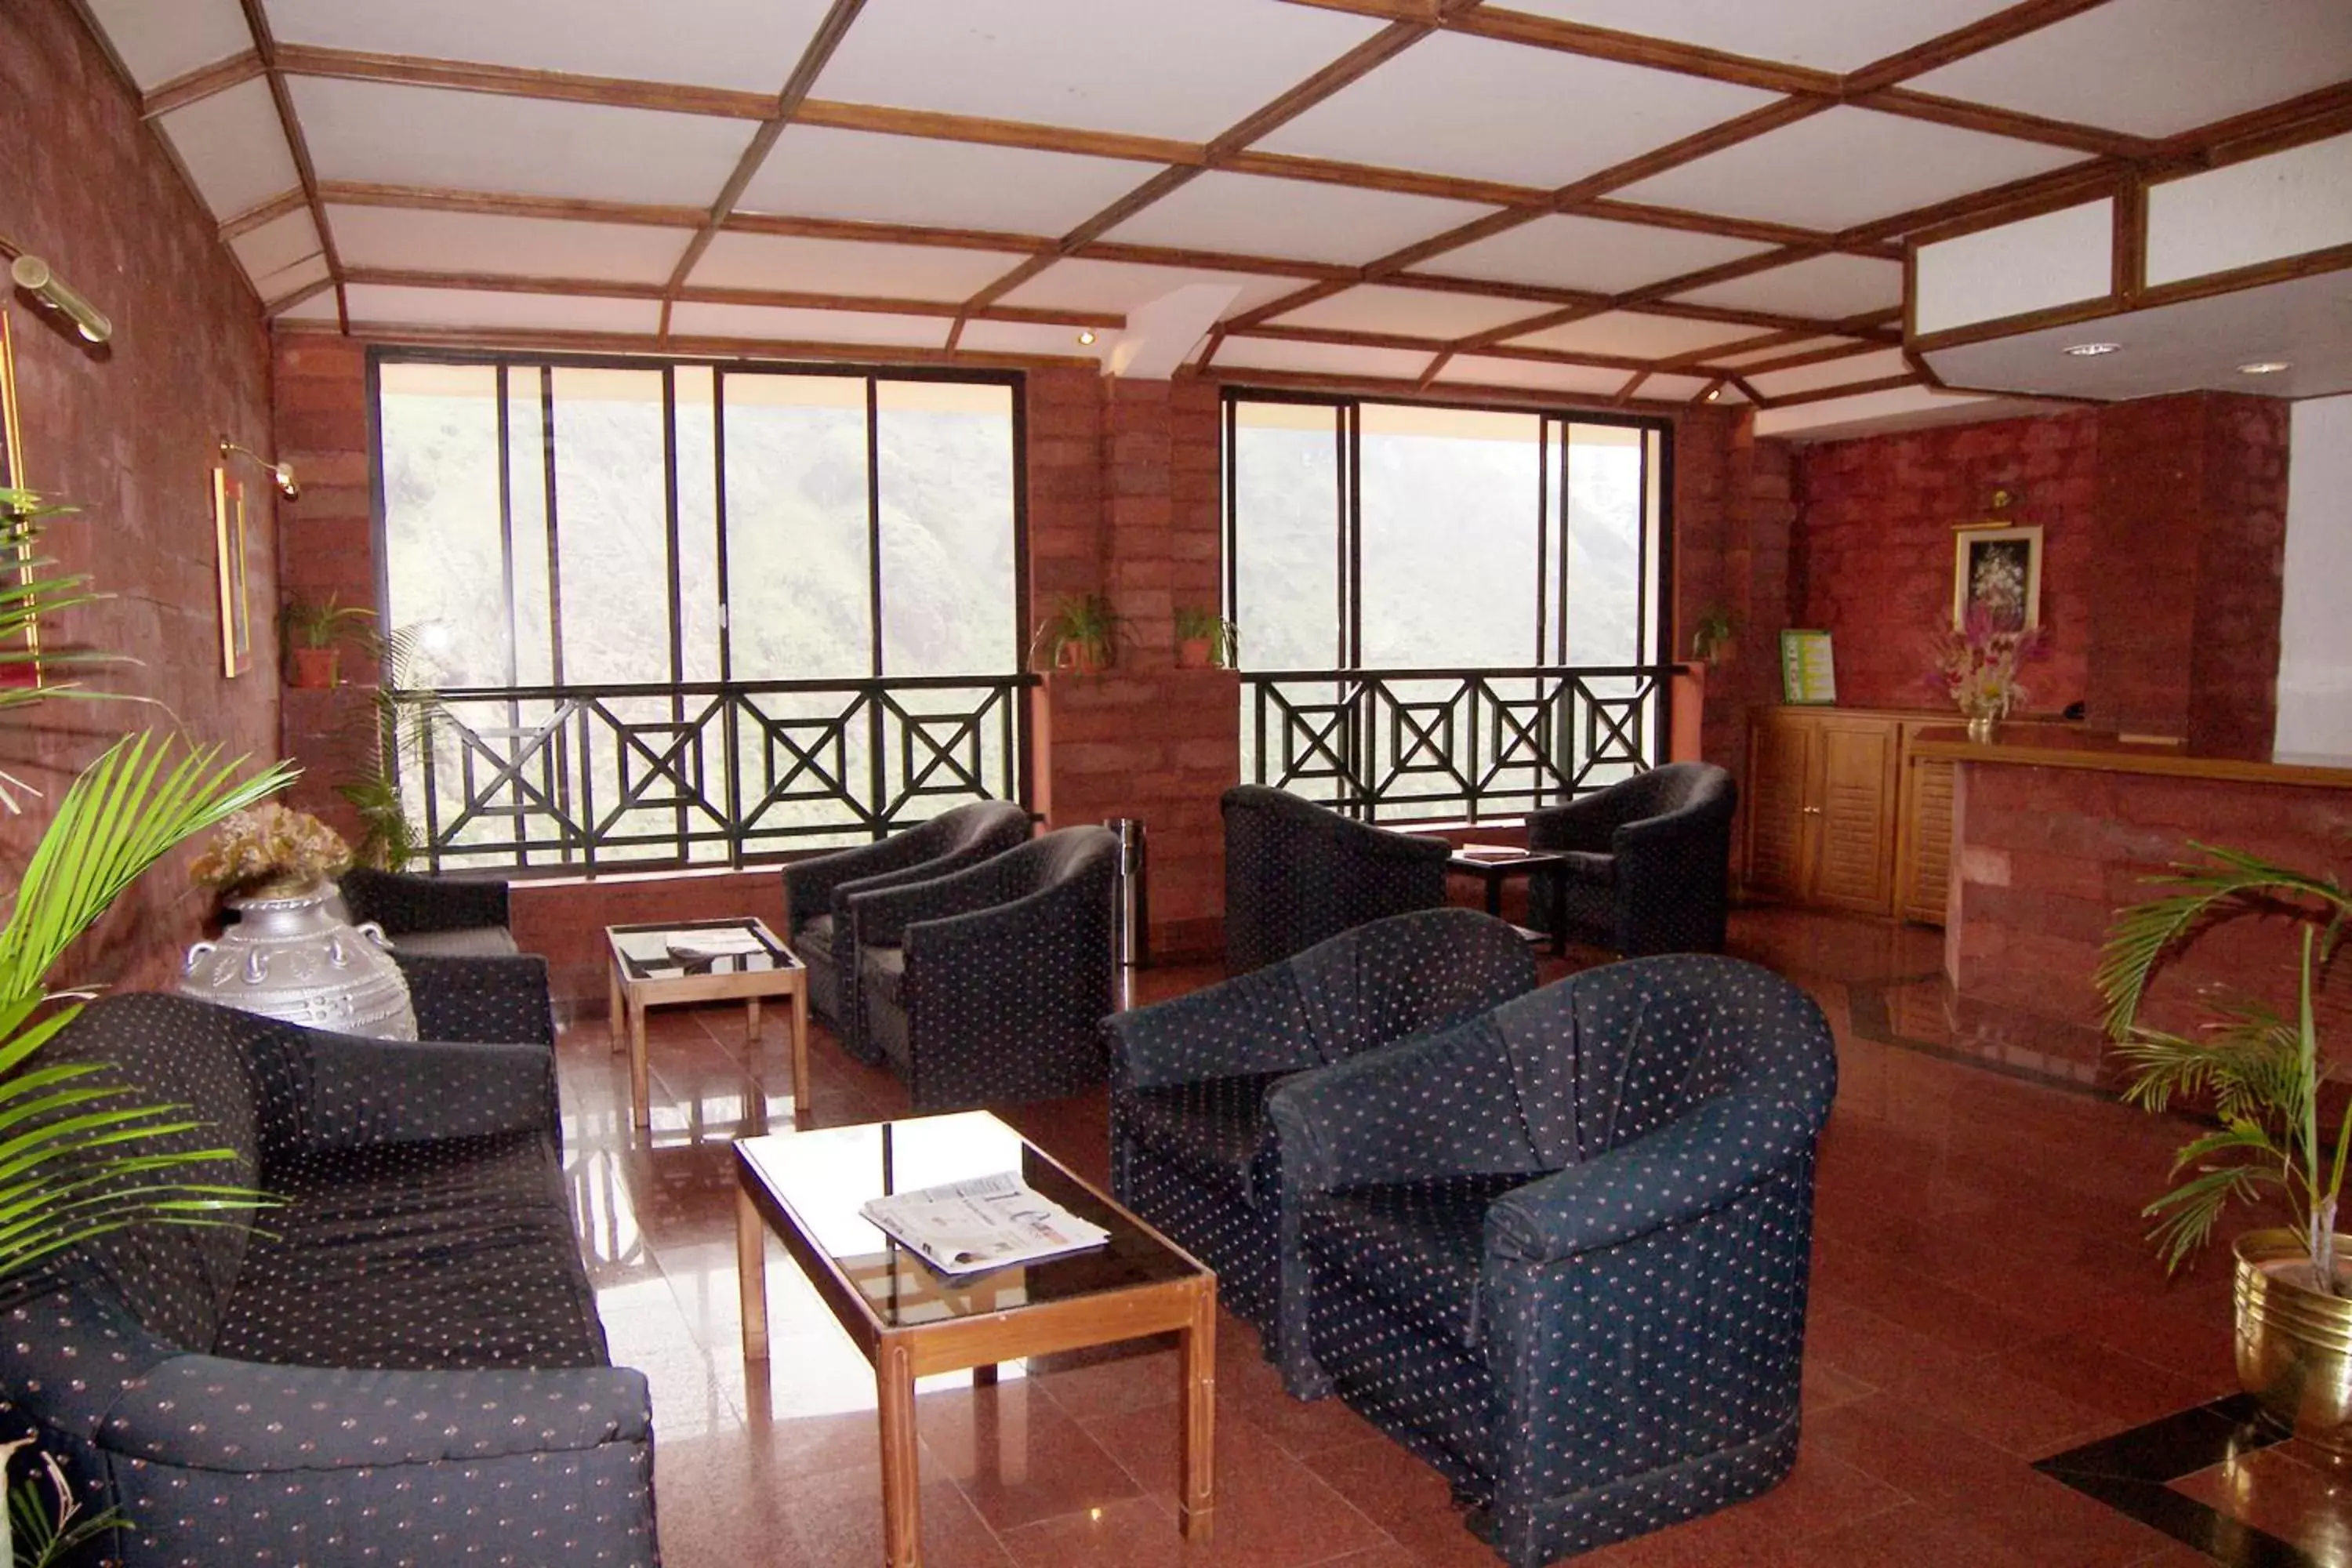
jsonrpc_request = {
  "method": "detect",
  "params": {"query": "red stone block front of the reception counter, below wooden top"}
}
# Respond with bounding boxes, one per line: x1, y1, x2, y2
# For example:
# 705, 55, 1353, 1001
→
1945, 764, 2352, 1051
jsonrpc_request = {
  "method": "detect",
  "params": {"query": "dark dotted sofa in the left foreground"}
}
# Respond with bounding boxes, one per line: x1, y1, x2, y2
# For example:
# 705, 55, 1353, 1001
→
0, 994, 659, 1568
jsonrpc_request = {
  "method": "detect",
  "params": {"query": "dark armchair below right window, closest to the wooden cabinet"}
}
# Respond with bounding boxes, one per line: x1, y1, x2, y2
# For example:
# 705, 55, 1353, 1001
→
1526, 762, 1740, 959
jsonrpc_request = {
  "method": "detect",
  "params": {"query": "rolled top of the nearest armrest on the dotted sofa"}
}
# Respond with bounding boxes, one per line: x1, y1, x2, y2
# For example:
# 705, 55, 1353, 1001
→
96, 1356, 654, 1472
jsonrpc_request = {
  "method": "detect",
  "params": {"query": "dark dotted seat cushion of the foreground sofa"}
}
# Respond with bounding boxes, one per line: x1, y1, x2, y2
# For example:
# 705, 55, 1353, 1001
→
214, 1133, 607, 1370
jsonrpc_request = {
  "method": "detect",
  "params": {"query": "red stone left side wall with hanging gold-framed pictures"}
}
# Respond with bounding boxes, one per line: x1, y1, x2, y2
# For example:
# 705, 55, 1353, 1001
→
0, 0, 278, 987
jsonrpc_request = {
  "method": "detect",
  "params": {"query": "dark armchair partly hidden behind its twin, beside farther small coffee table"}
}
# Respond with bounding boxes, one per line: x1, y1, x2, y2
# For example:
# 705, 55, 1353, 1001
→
783, 799, 1030, 1067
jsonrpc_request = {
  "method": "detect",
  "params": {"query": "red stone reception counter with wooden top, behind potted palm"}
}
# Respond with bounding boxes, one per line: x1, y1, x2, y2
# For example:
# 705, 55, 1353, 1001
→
1912, 724, 2352, 1067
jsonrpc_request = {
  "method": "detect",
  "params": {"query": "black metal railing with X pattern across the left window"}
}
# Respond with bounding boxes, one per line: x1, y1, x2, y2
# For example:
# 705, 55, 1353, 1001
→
400, 675, 1037, 869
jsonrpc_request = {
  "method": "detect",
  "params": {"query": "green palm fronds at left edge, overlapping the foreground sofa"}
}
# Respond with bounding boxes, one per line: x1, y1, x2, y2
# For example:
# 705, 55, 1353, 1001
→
0, 734, 292, 1563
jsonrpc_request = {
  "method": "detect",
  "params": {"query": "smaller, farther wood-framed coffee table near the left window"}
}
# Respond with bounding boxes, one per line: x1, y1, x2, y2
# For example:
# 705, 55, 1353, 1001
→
604, 914, 809, 1126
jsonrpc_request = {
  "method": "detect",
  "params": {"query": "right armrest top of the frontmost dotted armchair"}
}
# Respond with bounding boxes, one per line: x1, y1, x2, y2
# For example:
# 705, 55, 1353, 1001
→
1486, 1093, 1813, 1265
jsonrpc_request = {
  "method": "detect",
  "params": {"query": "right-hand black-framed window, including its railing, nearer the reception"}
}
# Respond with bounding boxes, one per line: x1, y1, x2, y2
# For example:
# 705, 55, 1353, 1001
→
1225, 390, 1672, 820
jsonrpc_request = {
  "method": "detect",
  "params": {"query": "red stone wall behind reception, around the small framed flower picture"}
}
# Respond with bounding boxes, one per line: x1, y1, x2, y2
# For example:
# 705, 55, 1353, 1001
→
1795, 409, 2105, 713
